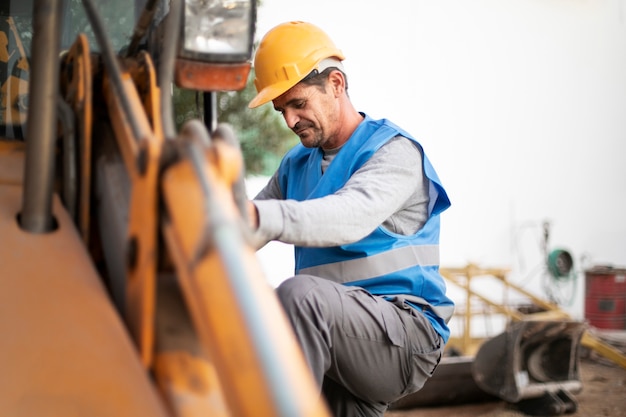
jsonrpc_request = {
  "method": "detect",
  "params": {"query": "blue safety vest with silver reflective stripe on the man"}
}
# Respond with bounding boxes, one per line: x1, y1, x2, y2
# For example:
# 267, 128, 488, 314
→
278, 116, 454, 341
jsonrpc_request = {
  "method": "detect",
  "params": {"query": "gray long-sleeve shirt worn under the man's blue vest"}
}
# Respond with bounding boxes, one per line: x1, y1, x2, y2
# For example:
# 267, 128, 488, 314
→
254, 136, 428, 247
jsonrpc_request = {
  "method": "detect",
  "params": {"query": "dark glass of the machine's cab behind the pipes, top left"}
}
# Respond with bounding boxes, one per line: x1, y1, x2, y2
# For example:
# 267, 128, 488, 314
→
0, 0, 136, 140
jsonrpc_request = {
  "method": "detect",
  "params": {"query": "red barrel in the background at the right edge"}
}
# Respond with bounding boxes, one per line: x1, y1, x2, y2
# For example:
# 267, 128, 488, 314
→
585, 266, 626, 330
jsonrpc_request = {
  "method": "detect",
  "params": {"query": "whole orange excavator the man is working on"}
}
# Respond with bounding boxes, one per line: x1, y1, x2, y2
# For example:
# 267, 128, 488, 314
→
0, 0, 328, 417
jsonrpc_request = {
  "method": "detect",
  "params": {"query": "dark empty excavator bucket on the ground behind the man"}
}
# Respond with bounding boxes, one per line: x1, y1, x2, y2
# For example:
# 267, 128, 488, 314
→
472, 320, 586, 415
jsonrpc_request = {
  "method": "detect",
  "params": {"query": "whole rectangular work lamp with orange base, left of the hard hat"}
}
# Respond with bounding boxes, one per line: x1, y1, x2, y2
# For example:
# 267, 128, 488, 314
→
176, 0, 256, 91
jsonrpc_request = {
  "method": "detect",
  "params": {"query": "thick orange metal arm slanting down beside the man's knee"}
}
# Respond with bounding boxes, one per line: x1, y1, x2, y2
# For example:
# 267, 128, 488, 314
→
158, 134, 329, 416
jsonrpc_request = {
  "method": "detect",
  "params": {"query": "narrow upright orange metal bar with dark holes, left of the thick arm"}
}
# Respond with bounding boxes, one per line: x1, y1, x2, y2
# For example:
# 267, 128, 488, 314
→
104, 57, 163, 368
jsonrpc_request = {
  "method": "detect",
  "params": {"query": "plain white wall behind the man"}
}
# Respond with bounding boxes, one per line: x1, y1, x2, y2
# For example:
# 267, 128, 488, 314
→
250, 0, 626, 315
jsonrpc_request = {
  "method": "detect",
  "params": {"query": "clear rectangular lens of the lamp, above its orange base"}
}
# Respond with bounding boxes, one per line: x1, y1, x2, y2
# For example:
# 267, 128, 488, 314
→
183, 0, 256, 62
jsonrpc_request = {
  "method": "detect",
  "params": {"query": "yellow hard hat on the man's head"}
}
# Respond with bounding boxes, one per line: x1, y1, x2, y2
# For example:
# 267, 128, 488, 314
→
248, 22, 345, 108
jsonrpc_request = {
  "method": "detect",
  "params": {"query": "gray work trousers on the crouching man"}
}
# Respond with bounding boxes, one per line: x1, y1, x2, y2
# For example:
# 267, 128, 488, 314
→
276, 275, 444, 417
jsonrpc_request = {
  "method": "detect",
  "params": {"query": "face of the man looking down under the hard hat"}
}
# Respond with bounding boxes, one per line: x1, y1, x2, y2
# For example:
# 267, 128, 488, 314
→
273, 78, 339, 149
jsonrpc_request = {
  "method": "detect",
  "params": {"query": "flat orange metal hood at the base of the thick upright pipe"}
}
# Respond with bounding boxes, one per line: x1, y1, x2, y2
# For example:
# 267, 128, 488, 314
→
0, 143, 168, 417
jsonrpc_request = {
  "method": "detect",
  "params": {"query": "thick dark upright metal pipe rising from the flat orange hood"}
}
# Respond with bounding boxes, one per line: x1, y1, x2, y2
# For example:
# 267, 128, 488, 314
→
20, 0, 62, 233
